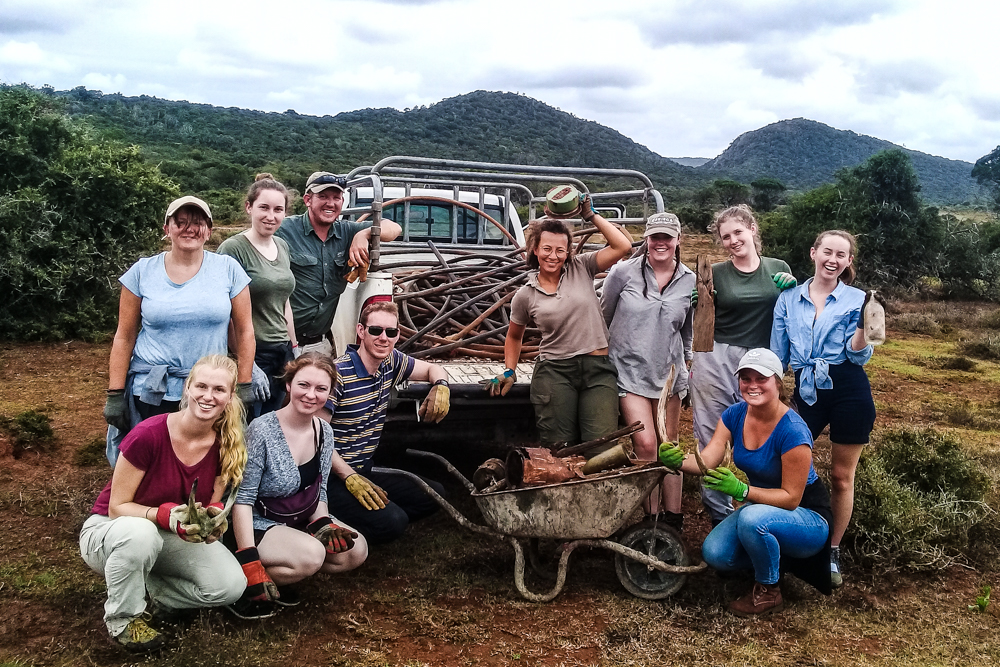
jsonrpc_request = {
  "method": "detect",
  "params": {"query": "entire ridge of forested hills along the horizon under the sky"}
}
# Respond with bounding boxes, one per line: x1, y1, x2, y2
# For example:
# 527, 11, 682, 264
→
50, 87, 978, 205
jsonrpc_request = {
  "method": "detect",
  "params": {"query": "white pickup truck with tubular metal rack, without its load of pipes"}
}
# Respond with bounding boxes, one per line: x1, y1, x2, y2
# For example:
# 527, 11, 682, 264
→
333, 156, 663, 462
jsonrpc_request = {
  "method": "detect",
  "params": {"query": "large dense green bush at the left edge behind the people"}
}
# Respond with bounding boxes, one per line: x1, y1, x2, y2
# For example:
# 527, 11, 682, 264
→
0, 87, 178, 340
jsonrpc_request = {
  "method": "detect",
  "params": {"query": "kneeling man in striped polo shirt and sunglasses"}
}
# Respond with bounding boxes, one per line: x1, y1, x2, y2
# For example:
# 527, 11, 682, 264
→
326, 301, 450, 543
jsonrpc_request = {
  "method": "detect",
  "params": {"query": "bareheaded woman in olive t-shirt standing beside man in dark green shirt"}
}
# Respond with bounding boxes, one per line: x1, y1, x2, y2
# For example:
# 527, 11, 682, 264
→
219, 174, 298, 420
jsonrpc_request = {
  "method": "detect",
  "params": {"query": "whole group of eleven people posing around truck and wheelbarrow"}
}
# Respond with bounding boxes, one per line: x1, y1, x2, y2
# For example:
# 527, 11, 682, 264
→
80, 172, 874, 651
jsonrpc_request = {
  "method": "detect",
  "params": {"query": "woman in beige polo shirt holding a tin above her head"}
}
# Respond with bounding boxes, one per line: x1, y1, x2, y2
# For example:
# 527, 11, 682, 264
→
487, 185, 632, 455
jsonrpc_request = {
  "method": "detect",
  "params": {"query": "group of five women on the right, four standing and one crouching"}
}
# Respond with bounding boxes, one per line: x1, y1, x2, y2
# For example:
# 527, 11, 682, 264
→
489, 196, 875, 615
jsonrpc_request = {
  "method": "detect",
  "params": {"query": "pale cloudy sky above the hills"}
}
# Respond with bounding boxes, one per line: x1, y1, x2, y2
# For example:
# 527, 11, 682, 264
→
0, 0, 1000, 162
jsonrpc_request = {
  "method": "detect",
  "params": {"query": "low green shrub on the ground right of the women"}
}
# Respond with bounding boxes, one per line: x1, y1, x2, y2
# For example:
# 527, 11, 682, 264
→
848, 428, 998, 570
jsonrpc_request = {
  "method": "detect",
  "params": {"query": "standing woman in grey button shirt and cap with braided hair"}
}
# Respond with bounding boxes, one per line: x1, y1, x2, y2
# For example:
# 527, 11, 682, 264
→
601, 213, 695, 530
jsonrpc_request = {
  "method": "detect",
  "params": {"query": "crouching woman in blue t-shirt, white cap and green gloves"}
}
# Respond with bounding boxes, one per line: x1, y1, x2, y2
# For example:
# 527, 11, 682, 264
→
660, 348, 832, 616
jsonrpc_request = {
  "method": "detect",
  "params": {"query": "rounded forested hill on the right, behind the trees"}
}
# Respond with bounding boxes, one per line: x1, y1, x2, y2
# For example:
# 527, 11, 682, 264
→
698, 118, 982, 204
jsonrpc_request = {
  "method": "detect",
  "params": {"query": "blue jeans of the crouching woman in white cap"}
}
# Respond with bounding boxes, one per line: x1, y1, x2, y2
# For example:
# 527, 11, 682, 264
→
701, 503, 830, 584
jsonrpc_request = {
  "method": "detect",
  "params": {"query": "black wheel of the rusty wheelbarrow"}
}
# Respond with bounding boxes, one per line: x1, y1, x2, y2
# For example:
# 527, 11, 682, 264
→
615, 521, 688, 600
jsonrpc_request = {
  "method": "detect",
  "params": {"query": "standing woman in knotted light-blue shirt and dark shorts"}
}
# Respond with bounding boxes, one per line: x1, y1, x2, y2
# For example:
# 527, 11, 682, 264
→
771, 230, 880, 587
